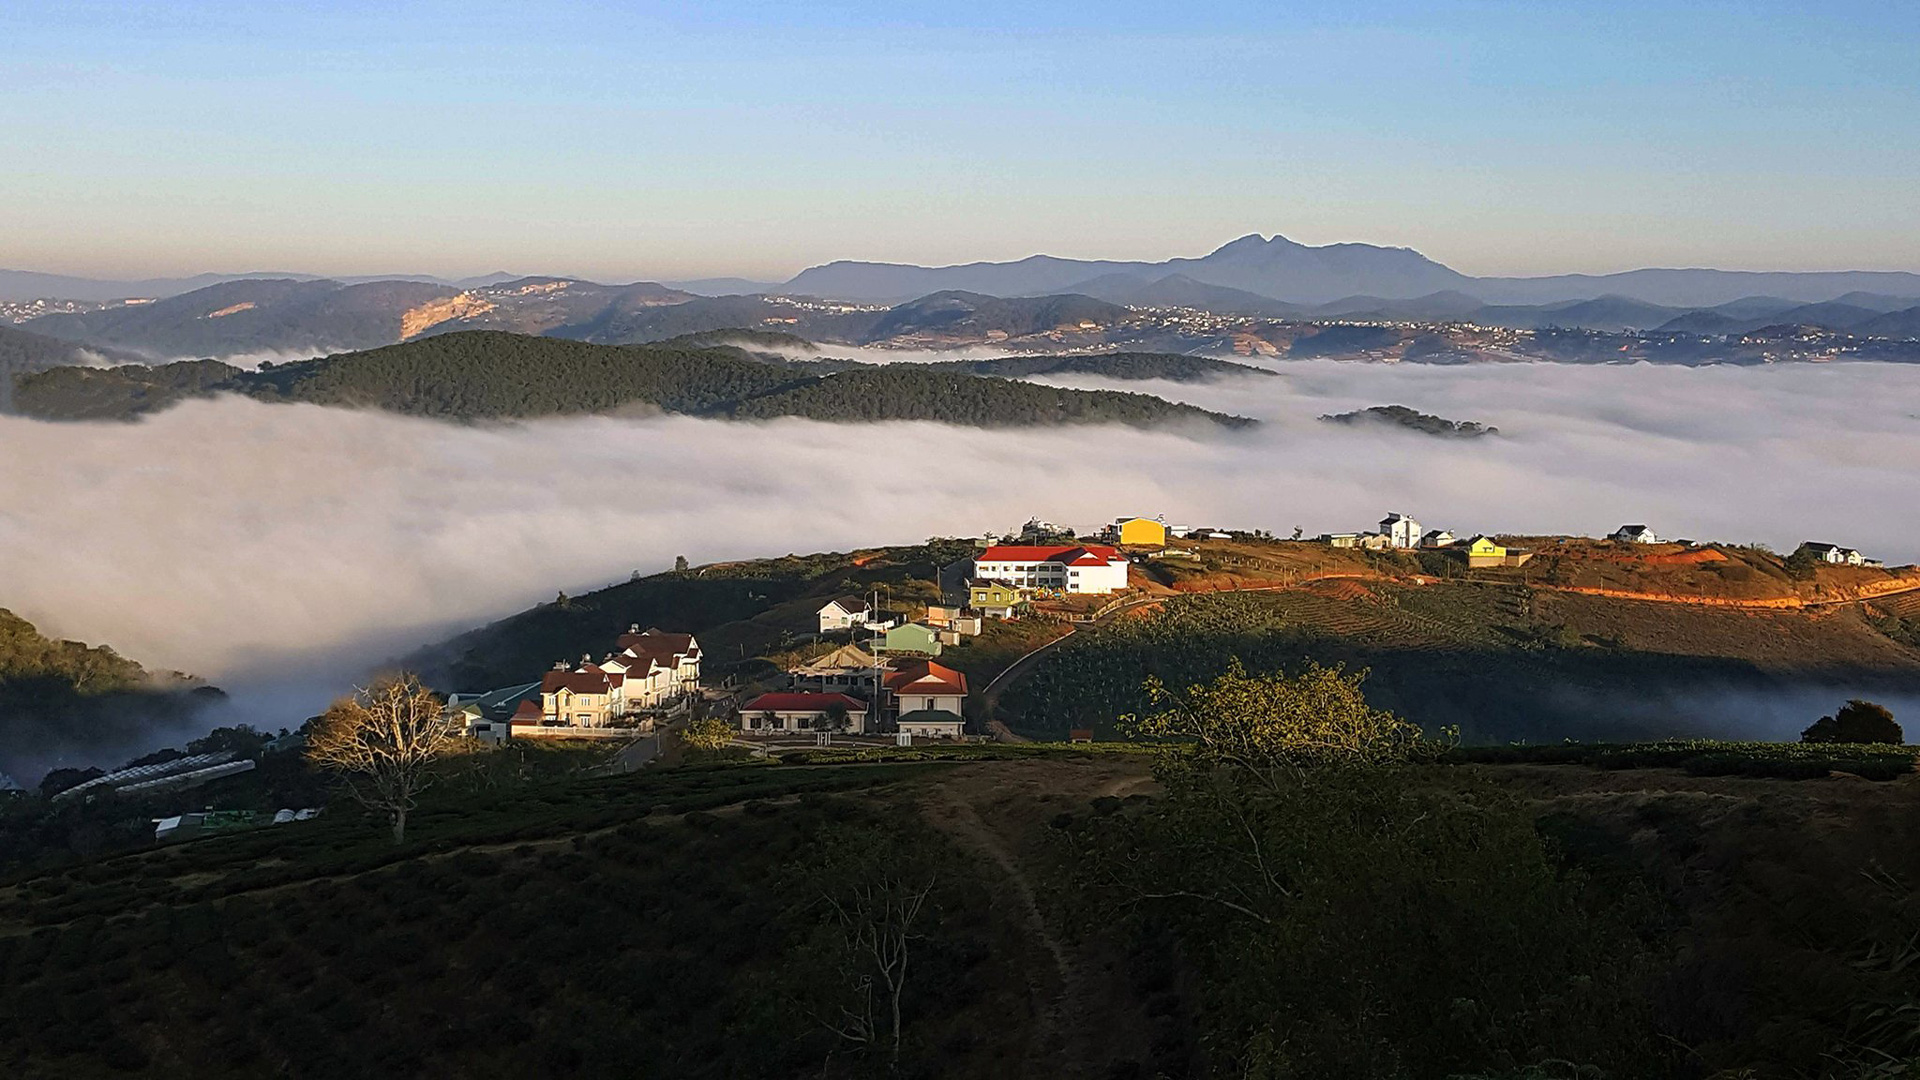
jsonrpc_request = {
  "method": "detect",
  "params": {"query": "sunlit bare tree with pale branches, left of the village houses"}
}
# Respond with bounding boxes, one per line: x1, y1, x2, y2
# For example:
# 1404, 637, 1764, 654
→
307, 673, 459, 844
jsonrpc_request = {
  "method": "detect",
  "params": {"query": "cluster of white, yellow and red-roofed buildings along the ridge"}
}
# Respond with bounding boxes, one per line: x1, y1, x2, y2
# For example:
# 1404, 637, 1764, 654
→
449, 513, 1880, 742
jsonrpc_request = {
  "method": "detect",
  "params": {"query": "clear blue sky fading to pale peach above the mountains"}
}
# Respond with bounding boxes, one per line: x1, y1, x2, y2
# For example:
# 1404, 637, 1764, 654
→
0, 0, 1920, 279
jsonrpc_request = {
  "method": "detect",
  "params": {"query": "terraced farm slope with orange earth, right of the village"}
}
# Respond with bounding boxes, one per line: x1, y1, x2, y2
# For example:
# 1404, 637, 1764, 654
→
1000, 580, 1920, 742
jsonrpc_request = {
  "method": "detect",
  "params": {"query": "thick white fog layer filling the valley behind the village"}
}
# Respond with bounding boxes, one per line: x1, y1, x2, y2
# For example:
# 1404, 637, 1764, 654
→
0, 361, 1920, 753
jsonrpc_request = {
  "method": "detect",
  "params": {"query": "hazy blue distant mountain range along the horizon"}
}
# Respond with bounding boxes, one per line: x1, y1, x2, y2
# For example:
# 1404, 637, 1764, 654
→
11, 228, 1920, 359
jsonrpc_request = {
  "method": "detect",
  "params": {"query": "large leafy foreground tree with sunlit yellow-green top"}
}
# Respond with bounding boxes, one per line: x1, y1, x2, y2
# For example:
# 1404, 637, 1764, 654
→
1068, 663, 1657, 1078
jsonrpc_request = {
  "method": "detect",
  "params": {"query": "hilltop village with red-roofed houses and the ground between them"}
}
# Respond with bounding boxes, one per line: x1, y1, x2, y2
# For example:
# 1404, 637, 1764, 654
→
447, 513, 1896, 749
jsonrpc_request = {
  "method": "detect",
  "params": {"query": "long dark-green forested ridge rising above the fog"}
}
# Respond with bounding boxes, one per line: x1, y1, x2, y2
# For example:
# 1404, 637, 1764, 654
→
15, 331, 1252, 427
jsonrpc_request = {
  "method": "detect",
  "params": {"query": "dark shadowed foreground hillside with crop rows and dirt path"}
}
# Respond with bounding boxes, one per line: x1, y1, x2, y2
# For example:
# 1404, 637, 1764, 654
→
0, 734, 1920, 1080
